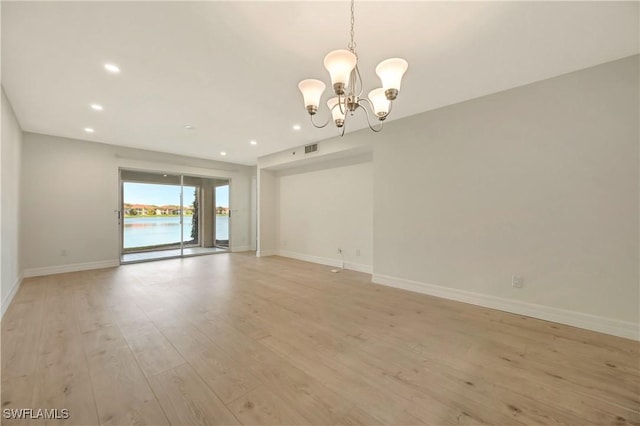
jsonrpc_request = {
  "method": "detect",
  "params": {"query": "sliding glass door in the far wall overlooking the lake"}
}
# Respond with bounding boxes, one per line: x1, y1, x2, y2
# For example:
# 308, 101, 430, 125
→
120, 169, 229, 263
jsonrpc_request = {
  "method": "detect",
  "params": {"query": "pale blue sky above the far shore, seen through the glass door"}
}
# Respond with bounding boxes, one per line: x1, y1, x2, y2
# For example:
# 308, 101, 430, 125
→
124, 182, 229, 207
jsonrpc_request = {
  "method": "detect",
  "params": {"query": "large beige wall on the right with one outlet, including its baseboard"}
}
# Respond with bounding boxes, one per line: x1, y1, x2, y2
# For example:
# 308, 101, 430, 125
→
372, 56, 640, 338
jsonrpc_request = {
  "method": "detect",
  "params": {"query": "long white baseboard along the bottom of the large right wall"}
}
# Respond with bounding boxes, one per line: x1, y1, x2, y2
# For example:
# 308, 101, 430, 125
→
372, 274, 640, 340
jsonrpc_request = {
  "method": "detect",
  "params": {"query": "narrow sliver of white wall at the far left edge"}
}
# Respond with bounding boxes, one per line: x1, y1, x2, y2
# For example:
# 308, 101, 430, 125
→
0, 89, 22, 315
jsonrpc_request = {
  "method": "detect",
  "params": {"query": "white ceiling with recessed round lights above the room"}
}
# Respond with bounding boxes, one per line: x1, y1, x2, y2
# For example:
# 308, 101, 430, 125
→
2, 1, 639, 164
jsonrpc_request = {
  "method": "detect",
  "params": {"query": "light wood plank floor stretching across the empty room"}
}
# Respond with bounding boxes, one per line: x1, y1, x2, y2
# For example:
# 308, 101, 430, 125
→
2, 254, 640, 425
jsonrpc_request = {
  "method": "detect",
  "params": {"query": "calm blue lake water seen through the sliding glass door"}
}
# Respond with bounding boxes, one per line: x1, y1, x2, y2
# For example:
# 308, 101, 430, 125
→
123, 215, 229, 249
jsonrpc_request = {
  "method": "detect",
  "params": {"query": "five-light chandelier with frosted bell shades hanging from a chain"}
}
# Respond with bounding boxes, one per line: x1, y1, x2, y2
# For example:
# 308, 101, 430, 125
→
298, 0, 409, 136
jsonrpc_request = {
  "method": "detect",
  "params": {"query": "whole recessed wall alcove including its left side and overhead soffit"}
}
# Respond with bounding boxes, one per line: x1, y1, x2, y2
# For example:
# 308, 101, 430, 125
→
258, 123, 373, 264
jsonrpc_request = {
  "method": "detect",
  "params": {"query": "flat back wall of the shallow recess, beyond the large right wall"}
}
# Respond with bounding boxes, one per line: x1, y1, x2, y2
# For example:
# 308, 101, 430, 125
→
278, 154, 373, 272
